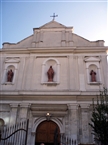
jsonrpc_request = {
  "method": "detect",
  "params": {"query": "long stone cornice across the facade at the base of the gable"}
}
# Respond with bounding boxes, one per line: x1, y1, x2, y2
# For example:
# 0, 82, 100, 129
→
0, 46, 108, 54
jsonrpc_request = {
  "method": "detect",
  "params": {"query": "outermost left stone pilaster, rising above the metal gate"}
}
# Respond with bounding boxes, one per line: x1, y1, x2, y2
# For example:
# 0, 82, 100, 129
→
10, 103, 18, 124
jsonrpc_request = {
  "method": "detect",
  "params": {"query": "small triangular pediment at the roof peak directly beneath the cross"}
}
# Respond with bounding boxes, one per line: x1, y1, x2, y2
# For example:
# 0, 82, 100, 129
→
40, 21, 66, 28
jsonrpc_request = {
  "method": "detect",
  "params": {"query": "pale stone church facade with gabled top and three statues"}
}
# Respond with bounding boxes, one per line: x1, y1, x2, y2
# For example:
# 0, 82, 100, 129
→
0, 20, 108, 145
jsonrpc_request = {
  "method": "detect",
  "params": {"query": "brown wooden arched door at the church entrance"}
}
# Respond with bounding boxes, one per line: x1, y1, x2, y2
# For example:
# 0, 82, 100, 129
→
35, 121, 60, 145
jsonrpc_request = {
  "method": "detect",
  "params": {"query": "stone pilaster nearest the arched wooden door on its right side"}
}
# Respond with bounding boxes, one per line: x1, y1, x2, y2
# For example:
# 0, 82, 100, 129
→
68, 104, 78, 144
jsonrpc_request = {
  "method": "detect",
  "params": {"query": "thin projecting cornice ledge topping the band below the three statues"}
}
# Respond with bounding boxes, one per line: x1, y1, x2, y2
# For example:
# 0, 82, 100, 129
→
0, 90, 99, 96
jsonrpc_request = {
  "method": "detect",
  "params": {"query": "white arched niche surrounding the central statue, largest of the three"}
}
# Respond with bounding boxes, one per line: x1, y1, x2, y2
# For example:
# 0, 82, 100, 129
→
41, 58, 60, 84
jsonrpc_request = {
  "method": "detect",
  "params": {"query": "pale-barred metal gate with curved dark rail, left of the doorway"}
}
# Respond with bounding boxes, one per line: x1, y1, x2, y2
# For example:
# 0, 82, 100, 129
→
0, 120, 29, 145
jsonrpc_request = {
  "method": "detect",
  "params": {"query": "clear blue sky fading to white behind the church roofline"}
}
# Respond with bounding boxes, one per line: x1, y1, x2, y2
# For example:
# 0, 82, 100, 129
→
0, 0, 108, 48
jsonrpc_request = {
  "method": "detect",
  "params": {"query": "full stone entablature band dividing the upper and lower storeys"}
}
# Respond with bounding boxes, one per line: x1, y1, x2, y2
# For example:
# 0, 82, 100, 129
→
1, 91, 99, 104
